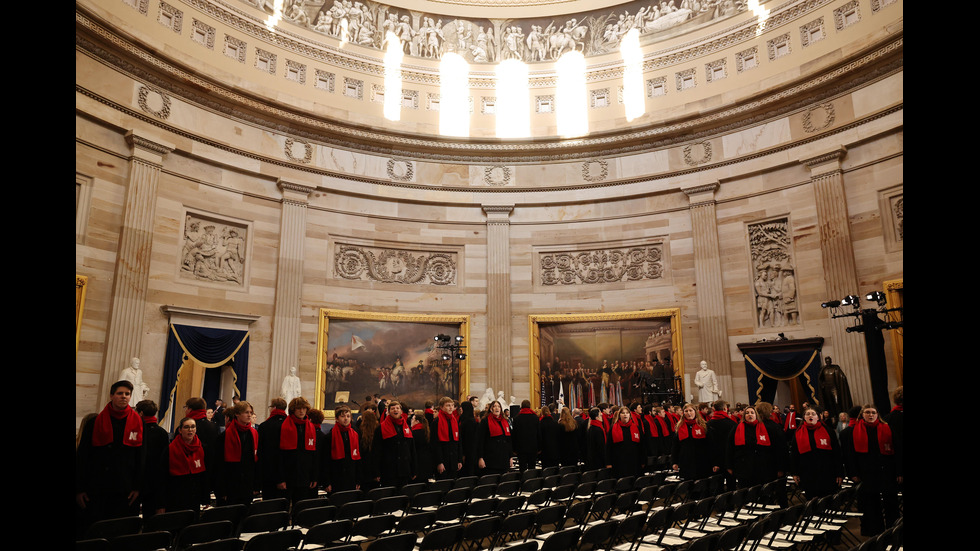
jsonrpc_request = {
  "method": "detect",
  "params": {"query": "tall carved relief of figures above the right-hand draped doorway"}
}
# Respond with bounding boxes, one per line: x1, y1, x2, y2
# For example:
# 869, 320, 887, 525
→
748, 218, 800, 329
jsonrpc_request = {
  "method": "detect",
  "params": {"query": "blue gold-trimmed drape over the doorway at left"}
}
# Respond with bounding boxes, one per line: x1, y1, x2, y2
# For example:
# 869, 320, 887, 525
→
160, 324, 249, 432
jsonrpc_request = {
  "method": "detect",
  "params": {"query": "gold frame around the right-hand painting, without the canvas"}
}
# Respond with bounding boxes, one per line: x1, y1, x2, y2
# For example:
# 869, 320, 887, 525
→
528, 308, 684, 408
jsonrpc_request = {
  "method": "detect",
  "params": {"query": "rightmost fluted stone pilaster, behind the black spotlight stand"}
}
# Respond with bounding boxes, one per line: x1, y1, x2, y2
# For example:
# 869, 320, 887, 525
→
800, 146, 872, 405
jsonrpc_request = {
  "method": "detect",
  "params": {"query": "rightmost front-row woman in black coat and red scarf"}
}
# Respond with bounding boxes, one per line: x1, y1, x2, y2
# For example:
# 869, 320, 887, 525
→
841, 404, 902, 536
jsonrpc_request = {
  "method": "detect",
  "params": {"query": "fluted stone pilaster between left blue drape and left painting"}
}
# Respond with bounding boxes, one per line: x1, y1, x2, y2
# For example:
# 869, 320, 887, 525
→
266, 180, 316, 404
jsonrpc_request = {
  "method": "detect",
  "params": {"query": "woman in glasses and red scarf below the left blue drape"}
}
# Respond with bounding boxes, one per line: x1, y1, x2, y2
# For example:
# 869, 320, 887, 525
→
164, 417, 211, 512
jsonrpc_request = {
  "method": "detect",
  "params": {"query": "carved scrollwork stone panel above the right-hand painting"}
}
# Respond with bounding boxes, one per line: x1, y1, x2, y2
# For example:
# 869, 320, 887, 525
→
540, 244, 664, 285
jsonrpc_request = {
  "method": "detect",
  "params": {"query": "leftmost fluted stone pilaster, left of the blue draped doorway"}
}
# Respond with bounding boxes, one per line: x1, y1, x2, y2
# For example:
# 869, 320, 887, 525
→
98, 130, 174, 405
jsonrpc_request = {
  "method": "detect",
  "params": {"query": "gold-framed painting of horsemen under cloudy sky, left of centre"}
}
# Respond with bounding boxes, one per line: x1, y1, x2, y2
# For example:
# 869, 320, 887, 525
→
314, 308, 469, 418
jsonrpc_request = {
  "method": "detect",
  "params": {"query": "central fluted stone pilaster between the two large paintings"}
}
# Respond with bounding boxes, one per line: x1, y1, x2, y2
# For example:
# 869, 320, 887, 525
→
483, 205, 514, 397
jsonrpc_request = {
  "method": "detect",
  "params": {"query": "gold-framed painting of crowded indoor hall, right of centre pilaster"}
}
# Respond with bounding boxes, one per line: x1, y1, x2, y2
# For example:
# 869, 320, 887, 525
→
528, 308, 684, 408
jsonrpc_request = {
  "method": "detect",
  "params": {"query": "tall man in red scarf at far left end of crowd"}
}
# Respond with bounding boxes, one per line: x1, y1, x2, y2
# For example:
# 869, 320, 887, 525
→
75, 380, 145, 536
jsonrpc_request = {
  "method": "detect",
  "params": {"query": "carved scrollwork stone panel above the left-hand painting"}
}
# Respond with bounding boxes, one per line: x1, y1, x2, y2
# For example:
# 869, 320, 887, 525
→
334, 244, 456, 285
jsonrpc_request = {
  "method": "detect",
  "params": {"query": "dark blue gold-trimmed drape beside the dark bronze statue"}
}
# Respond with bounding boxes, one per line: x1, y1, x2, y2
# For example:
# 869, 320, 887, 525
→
745, 349, 820, 404
